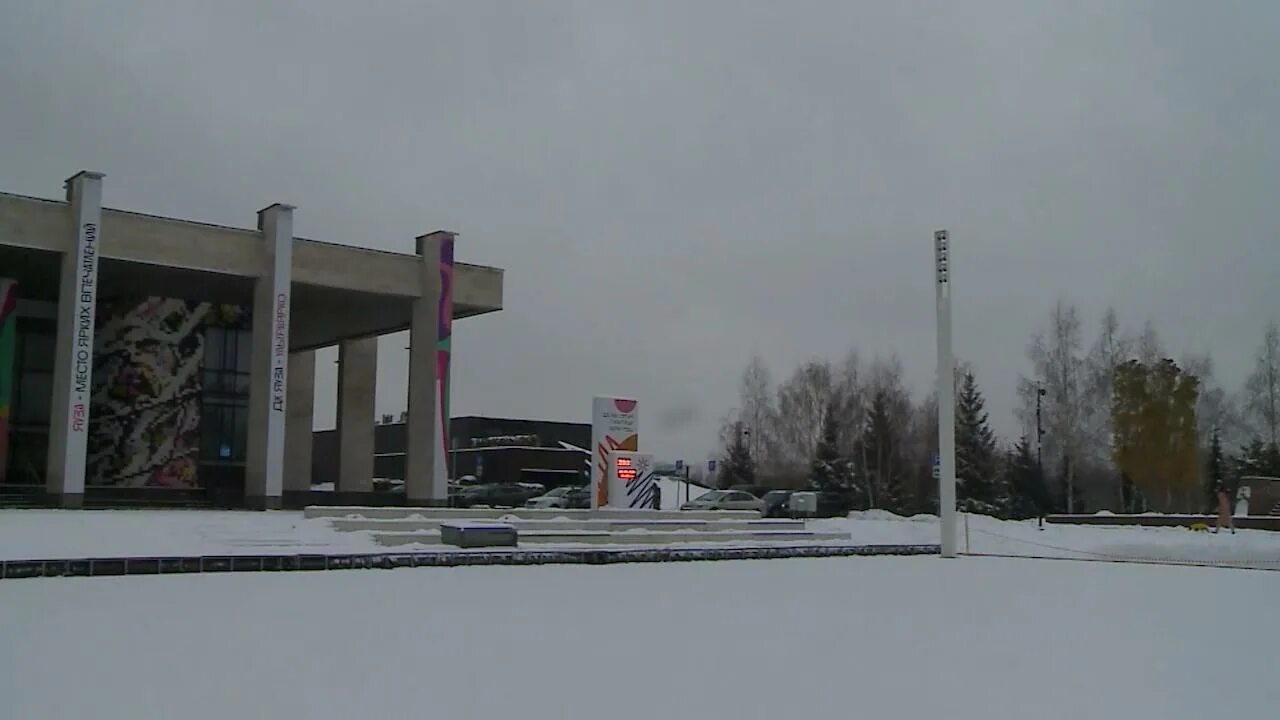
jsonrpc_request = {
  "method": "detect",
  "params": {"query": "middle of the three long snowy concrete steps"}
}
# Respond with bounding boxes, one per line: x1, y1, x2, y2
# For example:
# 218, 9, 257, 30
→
329, 518, 805, 533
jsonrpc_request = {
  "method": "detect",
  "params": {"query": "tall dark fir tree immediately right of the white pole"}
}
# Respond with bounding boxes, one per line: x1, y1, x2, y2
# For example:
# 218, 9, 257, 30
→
956, 372, 1002, 515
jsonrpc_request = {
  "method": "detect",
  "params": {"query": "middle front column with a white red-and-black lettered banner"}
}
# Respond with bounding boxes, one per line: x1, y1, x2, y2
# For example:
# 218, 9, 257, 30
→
244, 198, 293, 510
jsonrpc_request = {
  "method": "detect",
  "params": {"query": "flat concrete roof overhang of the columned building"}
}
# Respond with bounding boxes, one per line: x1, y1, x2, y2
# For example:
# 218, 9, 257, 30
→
0, 192, 503, 351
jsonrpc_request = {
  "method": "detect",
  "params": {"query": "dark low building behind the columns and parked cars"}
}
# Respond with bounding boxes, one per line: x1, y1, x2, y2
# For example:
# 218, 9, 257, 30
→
311, 416, 591, 487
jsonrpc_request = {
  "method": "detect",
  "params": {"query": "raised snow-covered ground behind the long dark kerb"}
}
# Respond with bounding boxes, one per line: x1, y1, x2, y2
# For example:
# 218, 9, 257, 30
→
0, 504, 1280, 570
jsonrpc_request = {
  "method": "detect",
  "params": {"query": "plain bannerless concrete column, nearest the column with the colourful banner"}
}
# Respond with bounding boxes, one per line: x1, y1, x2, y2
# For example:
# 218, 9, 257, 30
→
337, 337, 378, 492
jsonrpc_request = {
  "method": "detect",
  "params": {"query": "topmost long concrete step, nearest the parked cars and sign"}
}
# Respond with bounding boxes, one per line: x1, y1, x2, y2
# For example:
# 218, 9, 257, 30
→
302, 505, 760, 520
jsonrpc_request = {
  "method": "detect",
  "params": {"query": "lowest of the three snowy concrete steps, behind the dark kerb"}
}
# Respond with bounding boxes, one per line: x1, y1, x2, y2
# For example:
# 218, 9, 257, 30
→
372, 530, 850, 547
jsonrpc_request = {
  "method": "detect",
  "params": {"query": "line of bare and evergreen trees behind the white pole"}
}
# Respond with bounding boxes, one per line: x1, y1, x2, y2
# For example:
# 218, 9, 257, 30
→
719, 302, 1280, 518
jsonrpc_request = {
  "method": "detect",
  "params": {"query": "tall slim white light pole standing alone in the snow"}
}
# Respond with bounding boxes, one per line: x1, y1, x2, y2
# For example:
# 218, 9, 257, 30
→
933, 231, 956, 557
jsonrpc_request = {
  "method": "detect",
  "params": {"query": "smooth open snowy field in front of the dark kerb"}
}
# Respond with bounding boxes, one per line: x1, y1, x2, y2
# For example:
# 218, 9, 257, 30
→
0, 557, 1280, 720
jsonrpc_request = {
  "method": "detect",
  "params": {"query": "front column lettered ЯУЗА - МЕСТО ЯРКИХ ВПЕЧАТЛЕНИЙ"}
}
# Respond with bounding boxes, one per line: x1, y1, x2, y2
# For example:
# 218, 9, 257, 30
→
45, 172, 104, 507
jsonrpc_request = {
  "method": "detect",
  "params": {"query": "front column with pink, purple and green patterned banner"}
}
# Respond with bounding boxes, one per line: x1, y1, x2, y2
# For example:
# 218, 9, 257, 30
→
404, 231, 456, 505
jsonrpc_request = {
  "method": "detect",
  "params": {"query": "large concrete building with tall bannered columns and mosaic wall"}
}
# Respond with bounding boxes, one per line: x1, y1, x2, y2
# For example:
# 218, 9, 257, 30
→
0, 172, 503, 507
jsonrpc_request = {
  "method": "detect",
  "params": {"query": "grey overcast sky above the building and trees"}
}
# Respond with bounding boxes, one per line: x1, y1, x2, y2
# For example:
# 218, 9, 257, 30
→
0, 0, 1280, 459
